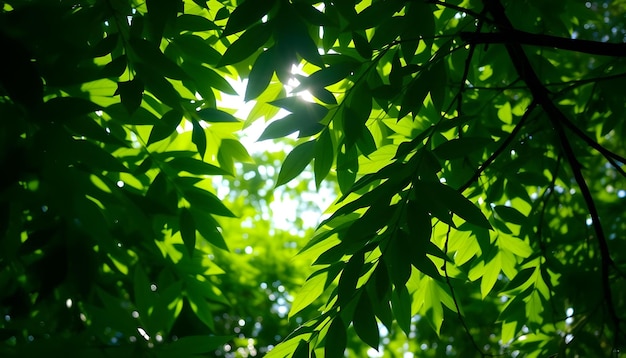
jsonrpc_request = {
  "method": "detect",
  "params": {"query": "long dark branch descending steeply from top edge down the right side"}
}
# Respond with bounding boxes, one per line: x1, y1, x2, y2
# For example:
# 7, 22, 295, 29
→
483, 0, 620, 339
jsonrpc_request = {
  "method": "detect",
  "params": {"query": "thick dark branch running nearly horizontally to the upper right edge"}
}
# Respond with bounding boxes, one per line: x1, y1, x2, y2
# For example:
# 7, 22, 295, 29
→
460, 29, 626, 57
